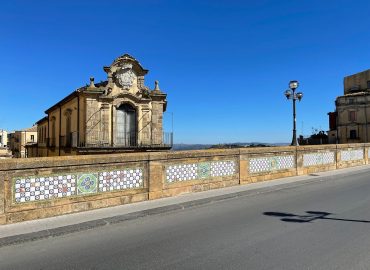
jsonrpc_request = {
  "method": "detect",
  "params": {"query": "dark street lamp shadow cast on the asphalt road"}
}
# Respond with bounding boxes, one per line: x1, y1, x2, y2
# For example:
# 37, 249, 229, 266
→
263, 211, 370, 223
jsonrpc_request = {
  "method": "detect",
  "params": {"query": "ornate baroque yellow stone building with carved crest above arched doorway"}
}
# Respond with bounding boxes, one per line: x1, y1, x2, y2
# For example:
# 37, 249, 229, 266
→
28, 54, 172, 156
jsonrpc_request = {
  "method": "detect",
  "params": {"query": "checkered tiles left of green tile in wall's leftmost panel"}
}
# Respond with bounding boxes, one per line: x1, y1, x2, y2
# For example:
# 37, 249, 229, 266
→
14, 174, 76, 203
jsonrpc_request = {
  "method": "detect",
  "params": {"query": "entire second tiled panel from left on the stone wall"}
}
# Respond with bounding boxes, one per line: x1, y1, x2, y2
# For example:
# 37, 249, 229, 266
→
166, 160, 236, 183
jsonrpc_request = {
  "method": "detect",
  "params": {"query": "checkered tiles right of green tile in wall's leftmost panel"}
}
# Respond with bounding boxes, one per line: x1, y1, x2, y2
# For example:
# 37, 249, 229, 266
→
99, 168, 144, 192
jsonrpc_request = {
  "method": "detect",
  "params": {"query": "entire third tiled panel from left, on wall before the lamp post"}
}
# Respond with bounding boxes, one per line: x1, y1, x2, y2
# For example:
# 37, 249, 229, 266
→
249, 156, 295, 173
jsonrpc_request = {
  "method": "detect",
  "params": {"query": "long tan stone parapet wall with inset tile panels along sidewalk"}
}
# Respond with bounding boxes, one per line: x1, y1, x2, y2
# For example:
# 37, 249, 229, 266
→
0, 144, 370, 224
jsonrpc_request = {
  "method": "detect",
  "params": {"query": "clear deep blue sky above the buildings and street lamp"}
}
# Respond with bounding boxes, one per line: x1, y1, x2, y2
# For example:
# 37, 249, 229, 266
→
0, 0, 370, 143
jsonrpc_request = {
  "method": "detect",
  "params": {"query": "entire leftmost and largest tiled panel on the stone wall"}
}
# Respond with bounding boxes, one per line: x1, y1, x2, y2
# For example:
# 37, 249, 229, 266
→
13, 168, 144, 203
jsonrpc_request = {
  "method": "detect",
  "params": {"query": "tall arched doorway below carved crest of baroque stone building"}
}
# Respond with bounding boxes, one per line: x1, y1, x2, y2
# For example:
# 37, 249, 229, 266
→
116, 103, 137, 146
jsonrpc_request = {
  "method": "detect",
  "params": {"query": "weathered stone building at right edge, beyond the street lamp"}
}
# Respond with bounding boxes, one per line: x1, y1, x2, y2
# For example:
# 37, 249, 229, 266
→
328, 69, 370, 143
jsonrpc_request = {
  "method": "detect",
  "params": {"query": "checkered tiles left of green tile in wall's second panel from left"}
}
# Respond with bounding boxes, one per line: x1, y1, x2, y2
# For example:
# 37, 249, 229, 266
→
166, 163, 198, 183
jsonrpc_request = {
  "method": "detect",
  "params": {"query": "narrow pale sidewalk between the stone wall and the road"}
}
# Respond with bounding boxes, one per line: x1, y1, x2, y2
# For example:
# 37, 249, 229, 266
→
0, 165, 370, 247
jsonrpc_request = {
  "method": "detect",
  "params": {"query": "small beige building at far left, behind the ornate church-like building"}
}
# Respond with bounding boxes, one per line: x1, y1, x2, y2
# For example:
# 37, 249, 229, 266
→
8, 125, 37, 158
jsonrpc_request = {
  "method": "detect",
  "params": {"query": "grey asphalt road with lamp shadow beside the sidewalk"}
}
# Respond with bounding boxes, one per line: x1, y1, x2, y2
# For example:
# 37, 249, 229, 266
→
0, 170, 370, 270
